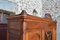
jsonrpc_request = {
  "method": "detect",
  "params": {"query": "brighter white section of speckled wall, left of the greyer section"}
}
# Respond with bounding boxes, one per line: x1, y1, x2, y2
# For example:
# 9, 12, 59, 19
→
7, 0, 43, 17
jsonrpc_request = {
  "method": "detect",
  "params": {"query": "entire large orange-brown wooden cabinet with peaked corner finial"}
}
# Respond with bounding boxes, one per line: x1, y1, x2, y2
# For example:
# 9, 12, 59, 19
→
7, 10, 56, 40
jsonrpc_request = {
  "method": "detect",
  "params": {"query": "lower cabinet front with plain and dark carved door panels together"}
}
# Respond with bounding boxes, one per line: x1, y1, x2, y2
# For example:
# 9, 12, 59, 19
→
25, 30, 53, 40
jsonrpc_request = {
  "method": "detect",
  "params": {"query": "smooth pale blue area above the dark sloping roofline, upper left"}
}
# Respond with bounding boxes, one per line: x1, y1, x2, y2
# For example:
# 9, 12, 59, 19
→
0, 0, 16, 12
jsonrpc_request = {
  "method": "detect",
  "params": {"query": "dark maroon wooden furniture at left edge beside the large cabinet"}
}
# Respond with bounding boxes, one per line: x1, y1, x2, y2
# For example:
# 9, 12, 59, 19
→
0, 23, 7, 40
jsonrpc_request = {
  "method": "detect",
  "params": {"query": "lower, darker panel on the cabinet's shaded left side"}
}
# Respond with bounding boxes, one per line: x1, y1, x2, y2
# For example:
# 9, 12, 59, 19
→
8, 29, 22, 40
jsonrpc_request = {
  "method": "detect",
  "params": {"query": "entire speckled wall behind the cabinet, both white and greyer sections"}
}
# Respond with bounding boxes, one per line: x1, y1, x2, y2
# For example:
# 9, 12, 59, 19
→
8, 0, 60, 18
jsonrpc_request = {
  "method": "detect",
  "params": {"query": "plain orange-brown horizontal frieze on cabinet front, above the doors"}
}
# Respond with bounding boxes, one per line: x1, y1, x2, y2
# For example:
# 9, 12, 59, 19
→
26, 21, 48, 29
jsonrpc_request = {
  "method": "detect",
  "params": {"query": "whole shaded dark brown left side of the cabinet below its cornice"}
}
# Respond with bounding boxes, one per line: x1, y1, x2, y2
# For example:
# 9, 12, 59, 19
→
8, 20, 23, 40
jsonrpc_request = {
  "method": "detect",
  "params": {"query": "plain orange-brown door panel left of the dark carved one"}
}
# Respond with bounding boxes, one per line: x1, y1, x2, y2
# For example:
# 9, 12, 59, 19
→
26, 32, 40, 40
